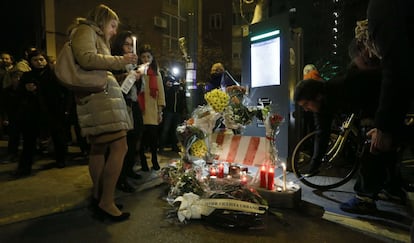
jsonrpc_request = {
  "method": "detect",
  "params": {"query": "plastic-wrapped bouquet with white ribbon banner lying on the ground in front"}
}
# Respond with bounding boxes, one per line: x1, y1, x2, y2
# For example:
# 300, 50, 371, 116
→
161, 160, 268, 229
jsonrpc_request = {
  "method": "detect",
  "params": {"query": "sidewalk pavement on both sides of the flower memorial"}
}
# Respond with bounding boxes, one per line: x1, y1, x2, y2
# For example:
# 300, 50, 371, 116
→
0, 142, 414, 242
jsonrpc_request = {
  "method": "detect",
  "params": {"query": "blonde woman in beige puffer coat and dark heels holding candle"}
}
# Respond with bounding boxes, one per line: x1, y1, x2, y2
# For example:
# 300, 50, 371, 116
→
69, 4, 137, 222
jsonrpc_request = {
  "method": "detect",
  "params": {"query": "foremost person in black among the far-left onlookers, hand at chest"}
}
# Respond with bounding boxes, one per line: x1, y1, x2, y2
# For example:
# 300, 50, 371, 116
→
15, 50, 68, 177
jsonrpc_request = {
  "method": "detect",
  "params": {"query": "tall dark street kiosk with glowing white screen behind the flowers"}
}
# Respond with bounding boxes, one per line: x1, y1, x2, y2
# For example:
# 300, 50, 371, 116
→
242, 11, 304, 163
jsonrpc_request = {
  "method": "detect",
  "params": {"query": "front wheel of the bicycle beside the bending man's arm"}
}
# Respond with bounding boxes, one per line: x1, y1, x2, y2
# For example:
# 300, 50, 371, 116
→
291, 131, 359, 190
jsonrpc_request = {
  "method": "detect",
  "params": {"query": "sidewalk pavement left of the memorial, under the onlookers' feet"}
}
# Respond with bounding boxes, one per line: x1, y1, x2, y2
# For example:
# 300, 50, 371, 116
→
0, 141, 170, 225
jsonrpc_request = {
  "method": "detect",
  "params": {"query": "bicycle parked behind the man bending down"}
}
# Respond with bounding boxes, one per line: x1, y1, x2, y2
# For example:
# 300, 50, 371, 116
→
291, 113, 368, 190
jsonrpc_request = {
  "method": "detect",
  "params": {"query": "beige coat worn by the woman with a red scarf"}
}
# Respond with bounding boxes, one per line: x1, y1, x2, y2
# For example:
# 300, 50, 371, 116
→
142, 73, 165, 125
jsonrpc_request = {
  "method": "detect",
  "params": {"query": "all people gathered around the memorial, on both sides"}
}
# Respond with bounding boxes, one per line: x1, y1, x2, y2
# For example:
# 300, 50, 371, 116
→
4, 0, 413, 224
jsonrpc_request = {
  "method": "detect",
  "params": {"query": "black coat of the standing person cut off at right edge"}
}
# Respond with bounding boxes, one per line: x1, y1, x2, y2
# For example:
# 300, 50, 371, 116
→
367, 0, 414, 135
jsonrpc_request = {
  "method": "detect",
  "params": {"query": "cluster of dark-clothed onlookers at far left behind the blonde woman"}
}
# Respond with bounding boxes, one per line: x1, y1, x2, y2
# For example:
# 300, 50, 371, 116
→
0, 48, 73, 177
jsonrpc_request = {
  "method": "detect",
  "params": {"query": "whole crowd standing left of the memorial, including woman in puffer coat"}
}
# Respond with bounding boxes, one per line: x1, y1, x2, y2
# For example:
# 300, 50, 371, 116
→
0, 4, 186, 222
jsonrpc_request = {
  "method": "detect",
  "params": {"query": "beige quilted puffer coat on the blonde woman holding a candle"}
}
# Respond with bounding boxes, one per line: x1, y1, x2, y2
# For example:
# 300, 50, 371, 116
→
72, 19, 132, 136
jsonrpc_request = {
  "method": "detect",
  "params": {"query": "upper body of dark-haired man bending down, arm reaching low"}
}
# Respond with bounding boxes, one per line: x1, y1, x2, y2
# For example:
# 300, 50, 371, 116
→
294, 66, 381, 176
